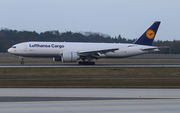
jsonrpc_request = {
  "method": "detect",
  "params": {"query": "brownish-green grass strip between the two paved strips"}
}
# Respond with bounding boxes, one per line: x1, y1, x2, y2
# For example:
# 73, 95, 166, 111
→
0, 67, 180, 88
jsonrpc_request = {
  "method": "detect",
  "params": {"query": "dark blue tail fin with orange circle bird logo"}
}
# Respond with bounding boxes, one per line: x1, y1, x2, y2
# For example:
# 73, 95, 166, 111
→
134, 21, 161, 46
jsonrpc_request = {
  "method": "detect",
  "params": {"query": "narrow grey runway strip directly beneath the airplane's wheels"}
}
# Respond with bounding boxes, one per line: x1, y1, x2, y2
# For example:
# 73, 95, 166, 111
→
0, 64, 180, 68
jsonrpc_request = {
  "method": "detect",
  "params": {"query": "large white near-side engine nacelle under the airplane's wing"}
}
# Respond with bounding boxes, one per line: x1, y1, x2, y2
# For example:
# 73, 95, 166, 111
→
61, 51, 79, 62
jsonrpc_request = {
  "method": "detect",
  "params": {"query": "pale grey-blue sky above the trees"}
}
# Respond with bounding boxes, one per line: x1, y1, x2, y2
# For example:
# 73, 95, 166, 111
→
0, 0, 180, 40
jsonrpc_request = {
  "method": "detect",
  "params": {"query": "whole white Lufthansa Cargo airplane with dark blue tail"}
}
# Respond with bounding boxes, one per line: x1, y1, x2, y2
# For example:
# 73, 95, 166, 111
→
8, 21, 161, 65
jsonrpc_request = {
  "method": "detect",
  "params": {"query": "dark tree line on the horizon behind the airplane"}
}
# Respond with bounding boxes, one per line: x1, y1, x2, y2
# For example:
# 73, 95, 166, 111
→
0, 29, 177, 54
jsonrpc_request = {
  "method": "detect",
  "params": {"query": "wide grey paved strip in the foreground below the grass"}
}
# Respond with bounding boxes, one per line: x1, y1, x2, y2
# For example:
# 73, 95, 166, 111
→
0, 88, 180, 113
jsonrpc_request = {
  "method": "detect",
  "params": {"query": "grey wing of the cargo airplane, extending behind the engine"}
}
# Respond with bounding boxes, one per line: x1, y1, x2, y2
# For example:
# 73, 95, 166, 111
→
78, 48, 119, 55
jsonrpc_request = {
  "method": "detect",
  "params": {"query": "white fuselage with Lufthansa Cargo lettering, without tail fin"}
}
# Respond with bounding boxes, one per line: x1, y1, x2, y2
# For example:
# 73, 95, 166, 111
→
8, 42, 159, 58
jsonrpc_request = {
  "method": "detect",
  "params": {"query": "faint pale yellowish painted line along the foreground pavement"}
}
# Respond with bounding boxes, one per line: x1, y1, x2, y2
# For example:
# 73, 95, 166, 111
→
0, 105, 180, 111
